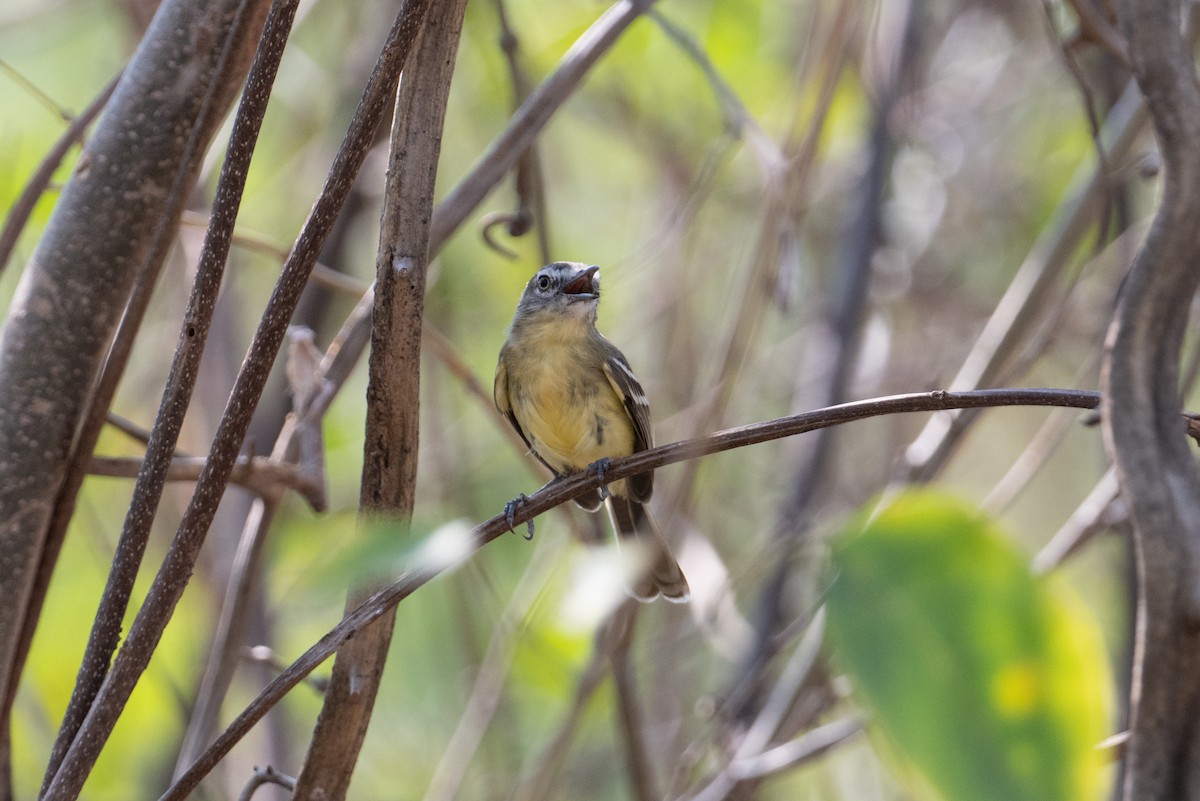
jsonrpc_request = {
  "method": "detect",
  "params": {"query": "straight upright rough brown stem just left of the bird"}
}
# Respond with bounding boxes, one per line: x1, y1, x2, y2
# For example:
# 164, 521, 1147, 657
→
293, 0, 467, 801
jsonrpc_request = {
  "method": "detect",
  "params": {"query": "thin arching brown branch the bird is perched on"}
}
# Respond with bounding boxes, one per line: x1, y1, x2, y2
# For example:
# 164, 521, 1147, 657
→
160, 389, 1100, 801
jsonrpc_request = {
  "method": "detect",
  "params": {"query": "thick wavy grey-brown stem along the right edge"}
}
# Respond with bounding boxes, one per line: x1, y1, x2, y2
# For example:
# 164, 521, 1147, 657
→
1102, 0, 1200, 801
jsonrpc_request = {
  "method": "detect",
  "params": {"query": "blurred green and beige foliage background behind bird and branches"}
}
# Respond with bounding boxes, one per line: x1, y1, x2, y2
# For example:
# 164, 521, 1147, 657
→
0, 0, 1153, 800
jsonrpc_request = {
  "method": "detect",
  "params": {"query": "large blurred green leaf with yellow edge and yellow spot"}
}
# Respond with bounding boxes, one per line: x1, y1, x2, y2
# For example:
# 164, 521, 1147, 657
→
829, 492, 1112, 801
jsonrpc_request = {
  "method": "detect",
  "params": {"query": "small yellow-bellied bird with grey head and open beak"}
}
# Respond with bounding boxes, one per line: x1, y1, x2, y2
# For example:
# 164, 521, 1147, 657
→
494, 261, 690, 603
